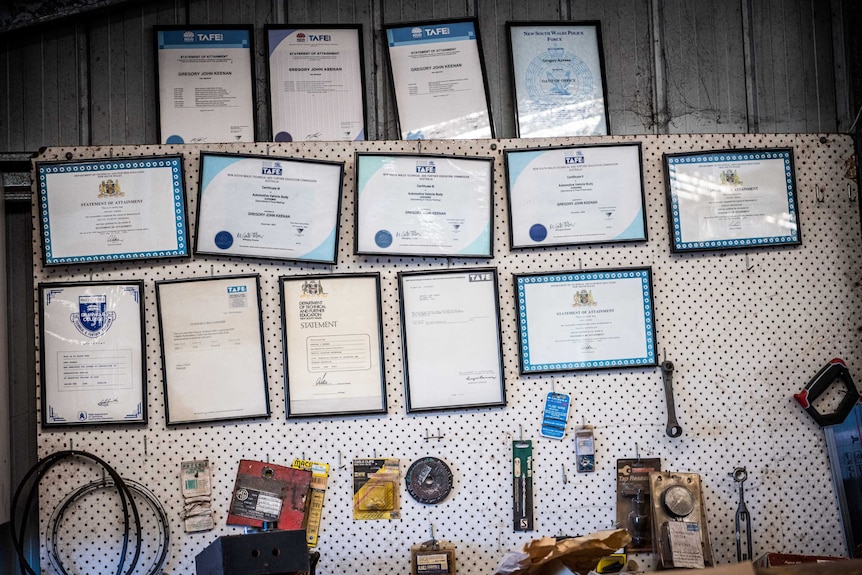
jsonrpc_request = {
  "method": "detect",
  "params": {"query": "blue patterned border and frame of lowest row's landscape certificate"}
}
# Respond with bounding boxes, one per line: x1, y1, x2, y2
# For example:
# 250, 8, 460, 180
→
513, 268, 658, 374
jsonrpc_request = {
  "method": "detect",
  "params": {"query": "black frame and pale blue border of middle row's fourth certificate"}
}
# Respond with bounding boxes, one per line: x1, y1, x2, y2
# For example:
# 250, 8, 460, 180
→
503, 142, 649, 250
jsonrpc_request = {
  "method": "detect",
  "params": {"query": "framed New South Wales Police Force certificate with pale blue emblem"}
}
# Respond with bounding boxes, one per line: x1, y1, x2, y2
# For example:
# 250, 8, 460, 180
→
506, 21, 610, 138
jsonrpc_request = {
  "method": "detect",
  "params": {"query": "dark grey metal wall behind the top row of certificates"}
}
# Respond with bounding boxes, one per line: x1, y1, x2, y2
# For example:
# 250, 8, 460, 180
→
0, 0, 851, 150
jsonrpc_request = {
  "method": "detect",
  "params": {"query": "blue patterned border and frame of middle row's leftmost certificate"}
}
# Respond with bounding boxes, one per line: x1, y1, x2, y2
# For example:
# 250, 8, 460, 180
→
36, 156, 189, 266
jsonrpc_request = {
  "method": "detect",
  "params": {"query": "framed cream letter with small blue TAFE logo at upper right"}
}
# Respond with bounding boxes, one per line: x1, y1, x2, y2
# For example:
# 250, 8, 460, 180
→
156, 275, 270, 425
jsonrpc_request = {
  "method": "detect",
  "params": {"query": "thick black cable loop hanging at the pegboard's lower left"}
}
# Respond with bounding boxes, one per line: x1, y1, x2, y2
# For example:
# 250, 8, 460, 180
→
11, 449, 141, 575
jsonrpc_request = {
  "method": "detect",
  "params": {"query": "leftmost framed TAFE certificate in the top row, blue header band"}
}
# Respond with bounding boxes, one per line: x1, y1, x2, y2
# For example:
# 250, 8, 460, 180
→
153, 26, 256, 144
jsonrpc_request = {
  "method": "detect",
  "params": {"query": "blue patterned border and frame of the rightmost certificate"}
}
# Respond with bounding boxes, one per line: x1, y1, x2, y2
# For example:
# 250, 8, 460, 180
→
664, 148, 802, 252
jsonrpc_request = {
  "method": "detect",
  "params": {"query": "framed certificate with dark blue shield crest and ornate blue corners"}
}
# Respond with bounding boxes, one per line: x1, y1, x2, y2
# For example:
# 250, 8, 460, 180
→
39, 281, 147, 427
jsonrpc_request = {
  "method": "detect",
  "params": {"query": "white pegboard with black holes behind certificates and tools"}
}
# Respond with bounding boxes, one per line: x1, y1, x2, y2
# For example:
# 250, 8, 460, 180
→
33, 134, 862, 575
